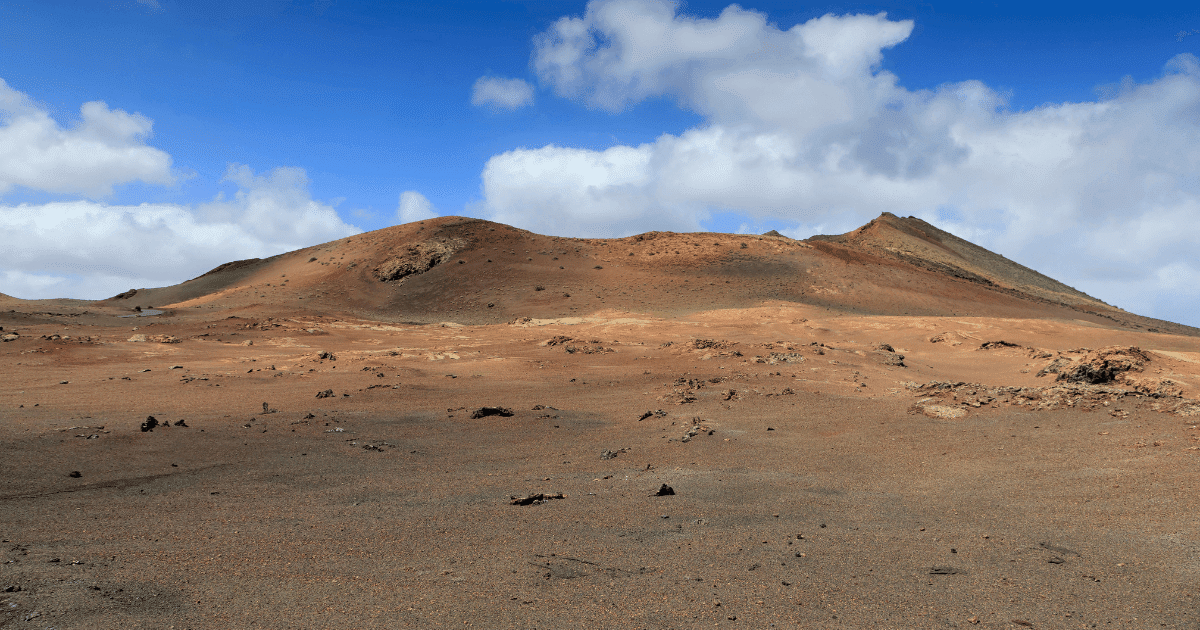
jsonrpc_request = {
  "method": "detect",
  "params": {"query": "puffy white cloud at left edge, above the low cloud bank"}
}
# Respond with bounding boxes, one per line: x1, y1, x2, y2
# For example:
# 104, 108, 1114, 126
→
0, 79, 175, 198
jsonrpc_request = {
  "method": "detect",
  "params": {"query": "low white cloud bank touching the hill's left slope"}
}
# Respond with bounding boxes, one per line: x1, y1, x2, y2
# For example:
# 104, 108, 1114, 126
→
0, 164, 361, 299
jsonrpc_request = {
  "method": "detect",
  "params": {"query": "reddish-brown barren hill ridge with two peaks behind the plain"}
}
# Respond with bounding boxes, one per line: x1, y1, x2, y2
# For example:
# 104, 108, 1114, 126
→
54, 214, 1180, 334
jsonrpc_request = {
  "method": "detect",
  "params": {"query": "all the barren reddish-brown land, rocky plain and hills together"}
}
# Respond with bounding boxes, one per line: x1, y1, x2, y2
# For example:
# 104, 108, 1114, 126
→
0, 216, 1200, 629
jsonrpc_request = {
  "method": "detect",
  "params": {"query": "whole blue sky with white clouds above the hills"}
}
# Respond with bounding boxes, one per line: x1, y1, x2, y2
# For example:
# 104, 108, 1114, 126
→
0, 0, 1200, 325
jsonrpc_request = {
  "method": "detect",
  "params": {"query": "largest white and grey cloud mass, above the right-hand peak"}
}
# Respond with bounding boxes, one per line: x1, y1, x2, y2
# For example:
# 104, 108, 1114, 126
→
472, 0, 1200, 324
